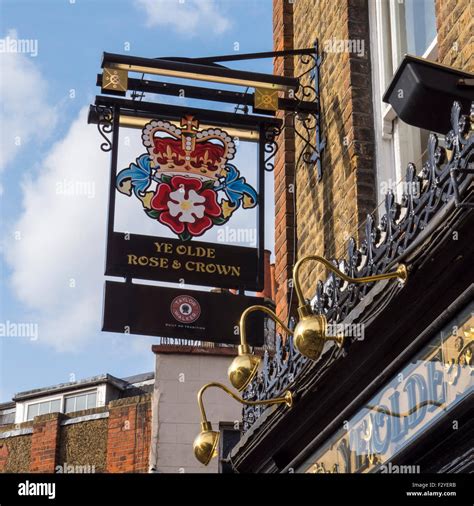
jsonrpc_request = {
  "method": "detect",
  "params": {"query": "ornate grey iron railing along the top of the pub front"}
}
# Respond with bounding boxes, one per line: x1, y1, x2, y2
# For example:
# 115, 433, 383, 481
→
243, 102, 474, 431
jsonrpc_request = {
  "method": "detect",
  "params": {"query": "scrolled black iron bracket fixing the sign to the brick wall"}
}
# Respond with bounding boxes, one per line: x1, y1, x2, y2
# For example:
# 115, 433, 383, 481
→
294, 39, 326, 181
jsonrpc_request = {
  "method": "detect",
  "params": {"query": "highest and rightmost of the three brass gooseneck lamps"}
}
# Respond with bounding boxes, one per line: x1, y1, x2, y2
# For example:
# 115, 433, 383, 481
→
293, 255, 408, 360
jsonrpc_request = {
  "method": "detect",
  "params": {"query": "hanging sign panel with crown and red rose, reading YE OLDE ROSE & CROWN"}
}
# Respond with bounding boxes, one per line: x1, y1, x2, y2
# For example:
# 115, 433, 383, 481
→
89, 96, 280, 291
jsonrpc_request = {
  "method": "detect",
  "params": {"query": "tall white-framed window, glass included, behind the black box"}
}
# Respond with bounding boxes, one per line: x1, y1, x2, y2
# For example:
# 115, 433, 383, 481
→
369, 0, 437, 208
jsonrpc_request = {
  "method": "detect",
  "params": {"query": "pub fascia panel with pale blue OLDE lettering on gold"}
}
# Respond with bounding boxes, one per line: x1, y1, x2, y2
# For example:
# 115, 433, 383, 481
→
297, 303, 474, 473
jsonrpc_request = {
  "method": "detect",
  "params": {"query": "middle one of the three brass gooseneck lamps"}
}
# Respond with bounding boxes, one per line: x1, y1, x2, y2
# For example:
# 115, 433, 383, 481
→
228, 305, 292, 392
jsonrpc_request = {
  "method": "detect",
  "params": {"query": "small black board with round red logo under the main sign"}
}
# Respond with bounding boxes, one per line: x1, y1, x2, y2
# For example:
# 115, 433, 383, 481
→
102, 281, 264, 346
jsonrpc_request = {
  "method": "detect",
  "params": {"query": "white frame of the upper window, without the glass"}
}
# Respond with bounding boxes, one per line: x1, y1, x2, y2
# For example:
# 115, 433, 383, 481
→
368, 0, 438, 208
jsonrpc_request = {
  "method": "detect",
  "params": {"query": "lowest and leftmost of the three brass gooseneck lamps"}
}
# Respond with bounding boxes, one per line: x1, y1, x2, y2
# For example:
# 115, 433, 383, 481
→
193, 382, 293, 466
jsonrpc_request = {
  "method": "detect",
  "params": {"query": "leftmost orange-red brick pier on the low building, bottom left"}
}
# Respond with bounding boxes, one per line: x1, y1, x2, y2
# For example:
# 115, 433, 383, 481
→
30, 413, 62, 473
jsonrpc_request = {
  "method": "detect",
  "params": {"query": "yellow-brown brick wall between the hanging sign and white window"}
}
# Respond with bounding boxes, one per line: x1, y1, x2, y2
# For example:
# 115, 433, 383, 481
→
273, 0, 376, 317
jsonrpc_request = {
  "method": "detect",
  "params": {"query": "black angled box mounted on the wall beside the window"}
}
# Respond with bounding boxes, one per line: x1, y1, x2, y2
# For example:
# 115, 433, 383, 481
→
383, 55, 474, 134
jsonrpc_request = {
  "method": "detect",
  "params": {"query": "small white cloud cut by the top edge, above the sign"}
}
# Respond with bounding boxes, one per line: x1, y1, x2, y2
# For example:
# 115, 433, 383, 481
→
136, 0, 231, 36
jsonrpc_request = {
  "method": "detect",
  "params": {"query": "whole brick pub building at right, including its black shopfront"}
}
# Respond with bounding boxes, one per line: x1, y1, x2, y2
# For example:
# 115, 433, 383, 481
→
227, 0, 474, 476
